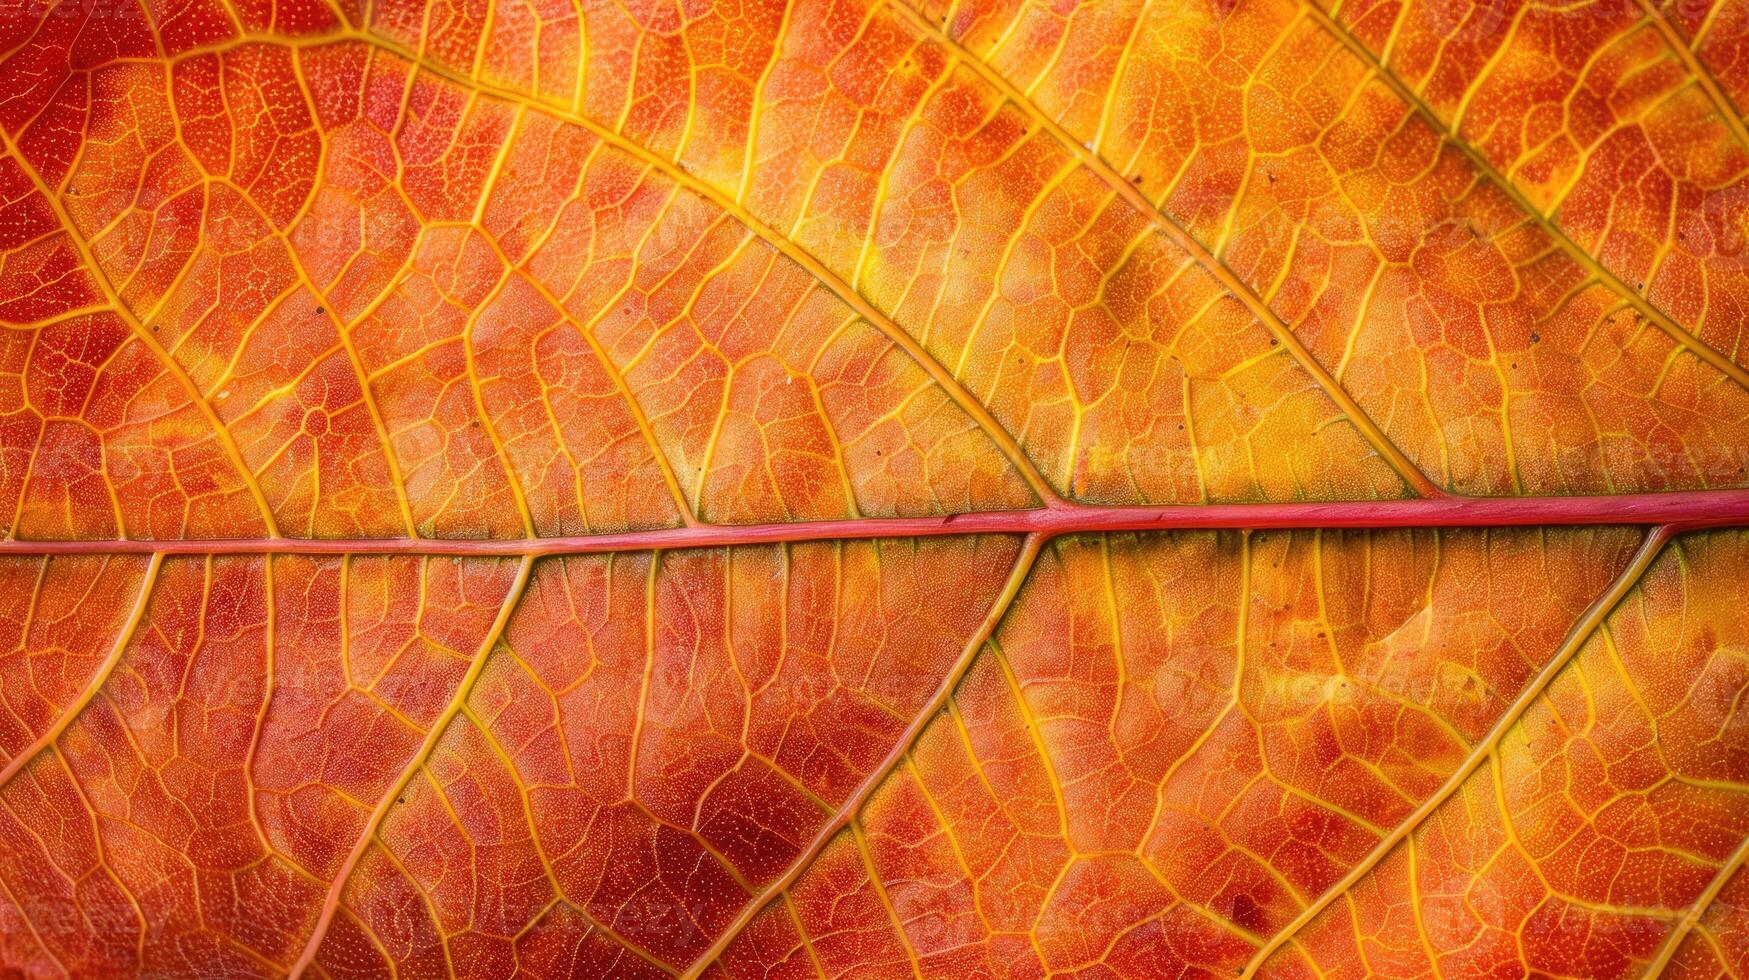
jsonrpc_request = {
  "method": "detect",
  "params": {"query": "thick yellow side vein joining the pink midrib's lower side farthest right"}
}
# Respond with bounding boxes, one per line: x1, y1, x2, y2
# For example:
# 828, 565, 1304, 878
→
1240, 525, 1674, 980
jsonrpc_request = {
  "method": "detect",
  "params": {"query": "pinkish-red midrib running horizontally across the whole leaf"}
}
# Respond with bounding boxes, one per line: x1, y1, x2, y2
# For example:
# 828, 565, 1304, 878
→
0, 488, 1749, 555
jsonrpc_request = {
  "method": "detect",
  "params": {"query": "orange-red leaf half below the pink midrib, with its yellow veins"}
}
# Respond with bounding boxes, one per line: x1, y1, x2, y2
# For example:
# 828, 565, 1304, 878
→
0, 529, 1749, 977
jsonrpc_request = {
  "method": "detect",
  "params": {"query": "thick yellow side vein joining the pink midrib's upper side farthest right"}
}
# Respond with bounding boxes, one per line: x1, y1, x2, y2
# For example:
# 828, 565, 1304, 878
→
888, 0, 1445, 497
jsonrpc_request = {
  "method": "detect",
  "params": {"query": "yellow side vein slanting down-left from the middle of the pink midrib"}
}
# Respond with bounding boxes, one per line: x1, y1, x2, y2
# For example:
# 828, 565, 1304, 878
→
680, 534, 1044, 980
